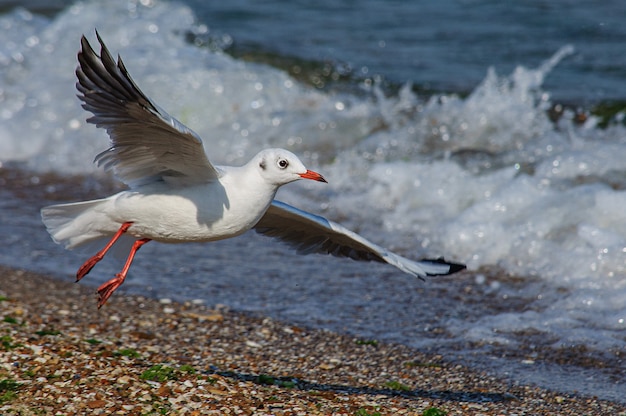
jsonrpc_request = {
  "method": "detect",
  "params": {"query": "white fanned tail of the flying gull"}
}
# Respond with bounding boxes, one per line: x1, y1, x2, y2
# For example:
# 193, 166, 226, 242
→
41, 199, 109, 249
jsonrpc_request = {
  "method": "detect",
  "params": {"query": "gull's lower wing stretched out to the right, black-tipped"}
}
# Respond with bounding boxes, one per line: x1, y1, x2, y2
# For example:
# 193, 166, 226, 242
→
255, 200, 465, 278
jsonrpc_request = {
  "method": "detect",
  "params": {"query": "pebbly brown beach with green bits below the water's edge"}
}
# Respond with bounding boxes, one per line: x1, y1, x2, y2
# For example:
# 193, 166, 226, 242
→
0, 266, 626, 415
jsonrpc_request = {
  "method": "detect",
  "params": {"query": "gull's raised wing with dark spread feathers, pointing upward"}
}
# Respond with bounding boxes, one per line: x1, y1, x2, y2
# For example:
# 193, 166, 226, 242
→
76, 32, 219, 187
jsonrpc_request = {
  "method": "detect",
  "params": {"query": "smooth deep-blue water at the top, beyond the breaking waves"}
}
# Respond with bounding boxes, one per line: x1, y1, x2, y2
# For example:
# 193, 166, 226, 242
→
186, 0, 626, 105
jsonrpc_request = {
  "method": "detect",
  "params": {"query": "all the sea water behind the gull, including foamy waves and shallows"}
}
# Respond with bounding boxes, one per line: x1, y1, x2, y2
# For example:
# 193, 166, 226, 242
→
0, 0, 626, 401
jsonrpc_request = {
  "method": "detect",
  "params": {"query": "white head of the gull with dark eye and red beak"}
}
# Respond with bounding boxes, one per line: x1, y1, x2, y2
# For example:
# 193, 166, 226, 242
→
253, 149, 326, 186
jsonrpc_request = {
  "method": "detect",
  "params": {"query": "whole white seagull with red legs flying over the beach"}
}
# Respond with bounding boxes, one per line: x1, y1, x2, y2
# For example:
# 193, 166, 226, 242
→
41, 31, 465, 308
